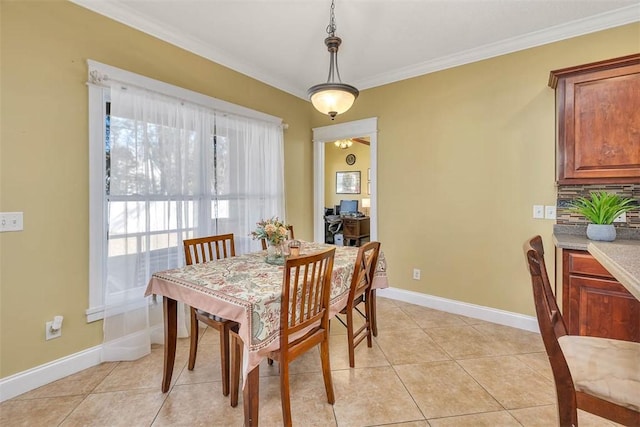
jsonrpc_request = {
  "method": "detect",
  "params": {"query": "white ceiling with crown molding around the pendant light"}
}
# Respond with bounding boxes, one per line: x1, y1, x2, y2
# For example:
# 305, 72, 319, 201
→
71, 0, 640, 98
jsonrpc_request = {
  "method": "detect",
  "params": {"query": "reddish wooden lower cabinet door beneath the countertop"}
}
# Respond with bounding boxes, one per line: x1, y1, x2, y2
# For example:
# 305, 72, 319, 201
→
567, 275, 640, 342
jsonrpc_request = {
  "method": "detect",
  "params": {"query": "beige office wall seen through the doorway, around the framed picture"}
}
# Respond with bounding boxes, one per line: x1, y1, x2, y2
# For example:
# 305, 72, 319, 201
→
324, 142, 371, 211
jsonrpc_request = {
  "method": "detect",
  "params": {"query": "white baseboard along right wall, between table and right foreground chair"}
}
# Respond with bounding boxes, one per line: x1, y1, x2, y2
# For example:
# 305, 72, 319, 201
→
376, 288, 540, 332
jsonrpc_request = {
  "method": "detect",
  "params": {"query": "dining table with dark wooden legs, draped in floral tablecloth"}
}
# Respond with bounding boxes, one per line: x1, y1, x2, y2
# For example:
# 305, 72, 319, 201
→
145, 242, 389, 426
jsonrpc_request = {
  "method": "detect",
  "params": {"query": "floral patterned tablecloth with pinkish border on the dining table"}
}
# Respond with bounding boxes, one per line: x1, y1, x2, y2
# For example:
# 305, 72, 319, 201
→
145, 242, 389, 378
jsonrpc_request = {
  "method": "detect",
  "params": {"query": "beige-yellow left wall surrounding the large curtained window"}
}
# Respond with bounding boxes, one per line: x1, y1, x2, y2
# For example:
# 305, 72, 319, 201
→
0, 1, 313, 377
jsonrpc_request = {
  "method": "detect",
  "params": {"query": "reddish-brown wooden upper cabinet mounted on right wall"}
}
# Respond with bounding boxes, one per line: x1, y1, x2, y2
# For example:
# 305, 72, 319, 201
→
549, 54, 640, 184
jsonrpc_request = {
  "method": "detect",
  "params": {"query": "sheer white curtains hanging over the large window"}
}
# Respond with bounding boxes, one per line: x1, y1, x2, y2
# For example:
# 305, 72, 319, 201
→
103, 84, 284, 360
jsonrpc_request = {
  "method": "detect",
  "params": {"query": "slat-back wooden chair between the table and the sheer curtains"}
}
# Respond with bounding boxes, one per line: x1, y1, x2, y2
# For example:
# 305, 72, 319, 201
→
184, 234, 238, 396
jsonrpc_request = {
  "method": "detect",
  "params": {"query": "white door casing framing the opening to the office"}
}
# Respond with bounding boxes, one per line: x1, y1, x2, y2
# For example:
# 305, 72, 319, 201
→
313, 117, 378, 243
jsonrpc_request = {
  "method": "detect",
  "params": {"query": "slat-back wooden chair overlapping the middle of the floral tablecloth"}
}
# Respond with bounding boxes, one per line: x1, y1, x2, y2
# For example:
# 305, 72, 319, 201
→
231, 248, 336, 426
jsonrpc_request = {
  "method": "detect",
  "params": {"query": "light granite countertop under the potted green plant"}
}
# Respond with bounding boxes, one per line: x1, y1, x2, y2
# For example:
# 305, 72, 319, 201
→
553, 226, 640, 300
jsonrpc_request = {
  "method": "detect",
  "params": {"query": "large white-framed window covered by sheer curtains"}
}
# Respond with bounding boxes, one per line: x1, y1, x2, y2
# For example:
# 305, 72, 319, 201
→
87, 61, 284, 321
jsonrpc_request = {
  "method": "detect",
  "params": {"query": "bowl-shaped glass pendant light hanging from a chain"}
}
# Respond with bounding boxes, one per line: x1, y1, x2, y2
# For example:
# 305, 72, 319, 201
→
307, 0, 359, 120
